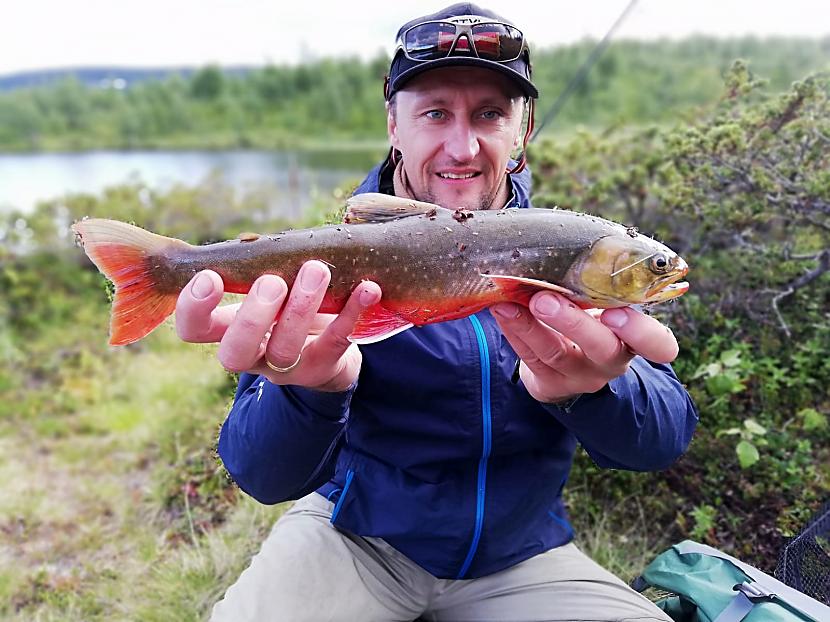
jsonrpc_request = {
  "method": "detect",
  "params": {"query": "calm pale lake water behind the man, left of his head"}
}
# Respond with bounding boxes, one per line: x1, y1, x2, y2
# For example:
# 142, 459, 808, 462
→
0, 150, 382, 217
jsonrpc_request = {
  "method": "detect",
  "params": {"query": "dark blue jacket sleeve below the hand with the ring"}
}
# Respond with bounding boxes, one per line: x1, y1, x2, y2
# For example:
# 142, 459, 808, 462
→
219, 374, 354, 503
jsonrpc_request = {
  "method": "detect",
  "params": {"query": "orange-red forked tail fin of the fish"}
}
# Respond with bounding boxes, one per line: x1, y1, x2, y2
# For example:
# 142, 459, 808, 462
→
72, 218, 189, 346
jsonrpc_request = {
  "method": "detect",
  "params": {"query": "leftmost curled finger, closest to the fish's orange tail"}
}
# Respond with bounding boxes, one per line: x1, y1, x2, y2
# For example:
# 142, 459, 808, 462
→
176, 270, 235, 343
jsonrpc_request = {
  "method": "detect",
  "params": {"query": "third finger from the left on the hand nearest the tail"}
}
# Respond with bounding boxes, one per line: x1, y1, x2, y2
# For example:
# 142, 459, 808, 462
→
265, 260, 331, 367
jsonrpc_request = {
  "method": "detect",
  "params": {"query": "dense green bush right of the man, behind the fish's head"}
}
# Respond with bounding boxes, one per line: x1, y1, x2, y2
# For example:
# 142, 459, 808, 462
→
531, 62, 830, 569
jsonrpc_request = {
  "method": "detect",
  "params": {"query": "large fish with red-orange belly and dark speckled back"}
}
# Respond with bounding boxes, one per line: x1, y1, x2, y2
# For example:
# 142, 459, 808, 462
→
72, 193, 689, 345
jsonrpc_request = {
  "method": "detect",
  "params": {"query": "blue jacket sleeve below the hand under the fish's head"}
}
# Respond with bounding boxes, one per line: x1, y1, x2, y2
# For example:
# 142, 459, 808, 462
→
543, 357, 698, 471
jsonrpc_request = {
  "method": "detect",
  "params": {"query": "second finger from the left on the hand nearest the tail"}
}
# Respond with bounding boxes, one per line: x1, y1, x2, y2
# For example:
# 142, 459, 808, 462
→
216, 274, 290, 371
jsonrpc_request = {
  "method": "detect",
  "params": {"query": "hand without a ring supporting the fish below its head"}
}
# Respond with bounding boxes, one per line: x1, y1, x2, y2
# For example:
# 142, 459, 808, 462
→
492, 292, 678, 403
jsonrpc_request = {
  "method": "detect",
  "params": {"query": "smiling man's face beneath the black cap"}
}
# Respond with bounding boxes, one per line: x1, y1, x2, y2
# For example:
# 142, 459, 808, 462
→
388, 67, 523, 209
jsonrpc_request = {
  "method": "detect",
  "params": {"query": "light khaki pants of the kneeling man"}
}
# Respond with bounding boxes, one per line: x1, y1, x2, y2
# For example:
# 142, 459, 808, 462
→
211, 493, 671, 622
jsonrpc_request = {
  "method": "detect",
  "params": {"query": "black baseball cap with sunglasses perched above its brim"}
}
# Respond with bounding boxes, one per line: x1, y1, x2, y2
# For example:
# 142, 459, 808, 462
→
385, 2, 539, 100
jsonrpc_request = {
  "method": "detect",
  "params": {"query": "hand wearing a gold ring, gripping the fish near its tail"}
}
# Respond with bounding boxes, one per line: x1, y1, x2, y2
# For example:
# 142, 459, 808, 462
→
176, 261, 381, 391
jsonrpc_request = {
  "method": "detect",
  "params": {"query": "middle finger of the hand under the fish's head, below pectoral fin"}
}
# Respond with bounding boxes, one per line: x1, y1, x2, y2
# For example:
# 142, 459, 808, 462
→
530, 292, 632, 367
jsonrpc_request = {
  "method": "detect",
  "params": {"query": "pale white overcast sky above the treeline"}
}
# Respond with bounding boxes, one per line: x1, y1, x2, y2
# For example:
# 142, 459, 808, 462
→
0, 0, 830, 74
